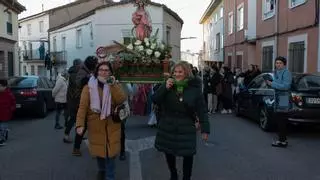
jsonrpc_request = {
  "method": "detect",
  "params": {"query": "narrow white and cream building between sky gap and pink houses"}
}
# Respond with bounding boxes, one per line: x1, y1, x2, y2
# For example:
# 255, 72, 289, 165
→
200, 0, 224, 62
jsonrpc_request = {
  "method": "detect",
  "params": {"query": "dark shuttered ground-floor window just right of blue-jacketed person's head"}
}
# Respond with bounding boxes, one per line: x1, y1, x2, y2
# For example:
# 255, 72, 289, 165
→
288, 41, 305, 73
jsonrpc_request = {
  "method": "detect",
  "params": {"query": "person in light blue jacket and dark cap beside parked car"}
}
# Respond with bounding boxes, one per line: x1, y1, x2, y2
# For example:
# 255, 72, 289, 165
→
266, 56, 292, 147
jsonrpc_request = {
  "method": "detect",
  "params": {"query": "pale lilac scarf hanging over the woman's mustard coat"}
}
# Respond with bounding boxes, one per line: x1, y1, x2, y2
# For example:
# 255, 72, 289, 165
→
88, 76, 111, 120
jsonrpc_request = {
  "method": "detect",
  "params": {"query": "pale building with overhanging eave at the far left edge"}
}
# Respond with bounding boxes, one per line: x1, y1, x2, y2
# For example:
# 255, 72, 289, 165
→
0, 0, 25, 77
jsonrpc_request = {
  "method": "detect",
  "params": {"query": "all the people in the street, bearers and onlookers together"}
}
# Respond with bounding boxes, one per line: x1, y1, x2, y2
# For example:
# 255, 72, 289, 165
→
0, 56, 291, 180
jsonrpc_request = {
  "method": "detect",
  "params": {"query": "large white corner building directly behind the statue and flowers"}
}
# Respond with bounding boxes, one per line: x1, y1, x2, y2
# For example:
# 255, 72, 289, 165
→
49, 2, 183, 68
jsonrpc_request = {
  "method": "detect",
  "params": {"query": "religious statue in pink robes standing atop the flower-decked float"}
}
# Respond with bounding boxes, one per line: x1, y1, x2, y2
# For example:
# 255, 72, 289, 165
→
132, 0, 152, 41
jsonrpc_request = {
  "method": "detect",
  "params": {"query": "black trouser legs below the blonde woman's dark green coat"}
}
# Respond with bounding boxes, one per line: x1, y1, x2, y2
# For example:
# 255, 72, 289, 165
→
165, 154, 193, 180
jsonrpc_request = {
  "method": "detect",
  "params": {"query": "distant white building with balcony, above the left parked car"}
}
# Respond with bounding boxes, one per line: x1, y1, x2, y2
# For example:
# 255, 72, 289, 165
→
19, 12, 49, 76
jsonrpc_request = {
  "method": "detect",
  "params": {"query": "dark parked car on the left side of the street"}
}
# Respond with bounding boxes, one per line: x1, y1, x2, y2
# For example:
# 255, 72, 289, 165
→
8, 76, 55, 118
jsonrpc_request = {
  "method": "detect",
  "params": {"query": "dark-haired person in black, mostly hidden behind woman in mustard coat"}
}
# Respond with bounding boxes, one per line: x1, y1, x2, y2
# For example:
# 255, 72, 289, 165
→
72, 56, 98, 156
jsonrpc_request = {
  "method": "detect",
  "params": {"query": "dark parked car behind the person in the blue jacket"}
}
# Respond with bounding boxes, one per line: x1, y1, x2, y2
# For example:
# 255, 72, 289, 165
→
235, 73, 320, 131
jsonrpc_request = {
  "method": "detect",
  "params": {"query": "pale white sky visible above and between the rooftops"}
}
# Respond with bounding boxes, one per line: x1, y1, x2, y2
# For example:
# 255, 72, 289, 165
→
18, 0, 211, 53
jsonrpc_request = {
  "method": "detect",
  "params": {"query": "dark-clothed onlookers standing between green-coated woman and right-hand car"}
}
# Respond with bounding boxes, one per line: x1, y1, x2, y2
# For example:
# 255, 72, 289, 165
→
203, 62, 261, 114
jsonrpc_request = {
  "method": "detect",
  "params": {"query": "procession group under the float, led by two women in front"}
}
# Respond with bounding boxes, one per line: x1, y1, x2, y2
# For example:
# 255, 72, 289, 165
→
48, 56, 210, 180
